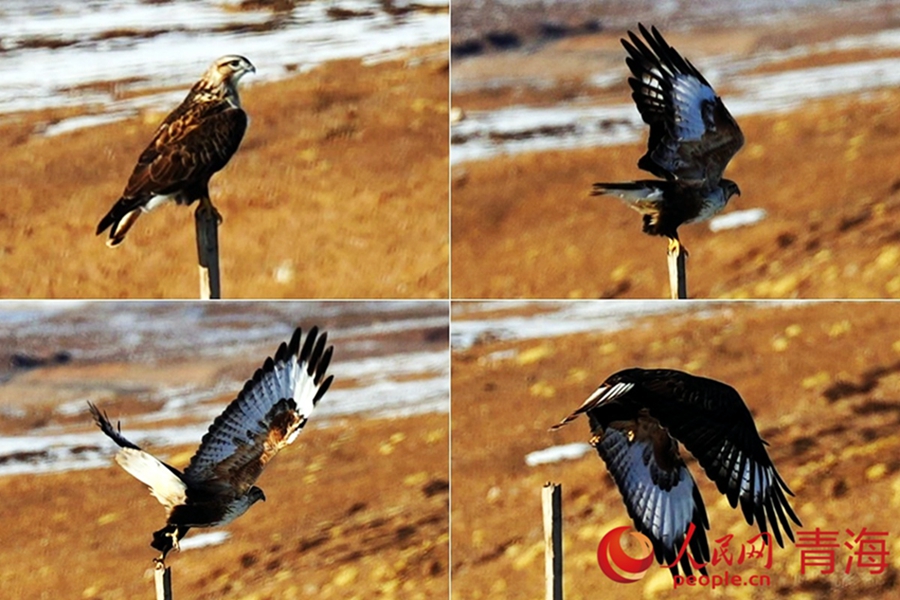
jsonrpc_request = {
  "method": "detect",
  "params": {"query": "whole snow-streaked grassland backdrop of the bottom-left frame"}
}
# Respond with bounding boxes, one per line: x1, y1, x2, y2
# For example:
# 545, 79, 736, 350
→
0, 302, 449, 598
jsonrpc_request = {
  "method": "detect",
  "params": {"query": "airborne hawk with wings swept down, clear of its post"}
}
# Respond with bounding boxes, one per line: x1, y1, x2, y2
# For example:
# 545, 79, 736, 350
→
552, 368, 801, 576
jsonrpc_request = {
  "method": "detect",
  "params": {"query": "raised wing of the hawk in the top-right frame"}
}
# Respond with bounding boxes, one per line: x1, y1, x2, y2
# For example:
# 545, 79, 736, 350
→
622, 24, 744, 189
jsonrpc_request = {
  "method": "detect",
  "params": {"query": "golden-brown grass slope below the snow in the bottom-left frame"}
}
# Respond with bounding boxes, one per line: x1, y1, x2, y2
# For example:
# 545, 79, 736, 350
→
0, 414, 449, 600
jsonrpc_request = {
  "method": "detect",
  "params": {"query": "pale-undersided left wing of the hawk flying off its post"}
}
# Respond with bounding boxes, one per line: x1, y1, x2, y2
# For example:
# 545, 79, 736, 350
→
591, 419, 710, 576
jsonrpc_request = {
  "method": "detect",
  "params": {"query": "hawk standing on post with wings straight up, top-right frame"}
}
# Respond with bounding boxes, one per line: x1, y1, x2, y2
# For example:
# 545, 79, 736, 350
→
591, 24, 744, 254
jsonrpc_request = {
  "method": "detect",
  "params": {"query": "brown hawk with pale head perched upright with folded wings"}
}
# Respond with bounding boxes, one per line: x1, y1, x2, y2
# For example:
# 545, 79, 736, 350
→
97, 55, 256, 248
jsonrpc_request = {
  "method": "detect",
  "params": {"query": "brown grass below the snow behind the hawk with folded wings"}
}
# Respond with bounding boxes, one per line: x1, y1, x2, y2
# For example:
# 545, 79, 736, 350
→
0, 45, 449, 298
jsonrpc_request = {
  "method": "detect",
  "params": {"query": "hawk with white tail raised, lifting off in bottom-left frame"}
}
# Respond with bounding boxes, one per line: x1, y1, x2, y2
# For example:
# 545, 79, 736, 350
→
88, 327, 334, 562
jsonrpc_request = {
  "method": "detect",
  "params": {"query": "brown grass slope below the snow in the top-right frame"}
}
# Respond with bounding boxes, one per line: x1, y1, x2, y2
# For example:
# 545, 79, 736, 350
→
451, 90, 900, 298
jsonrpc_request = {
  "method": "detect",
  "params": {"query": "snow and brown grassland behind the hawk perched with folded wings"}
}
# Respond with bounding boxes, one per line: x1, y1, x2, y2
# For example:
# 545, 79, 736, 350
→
0, 0, 449, 298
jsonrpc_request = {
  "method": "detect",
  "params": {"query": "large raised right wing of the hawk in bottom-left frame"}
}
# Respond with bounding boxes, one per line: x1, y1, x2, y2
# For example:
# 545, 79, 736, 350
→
184, 327, 333, 496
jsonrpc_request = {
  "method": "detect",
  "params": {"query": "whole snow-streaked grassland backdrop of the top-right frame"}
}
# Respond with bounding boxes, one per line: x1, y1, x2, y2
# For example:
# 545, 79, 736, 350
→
451, 0, 900, 298
